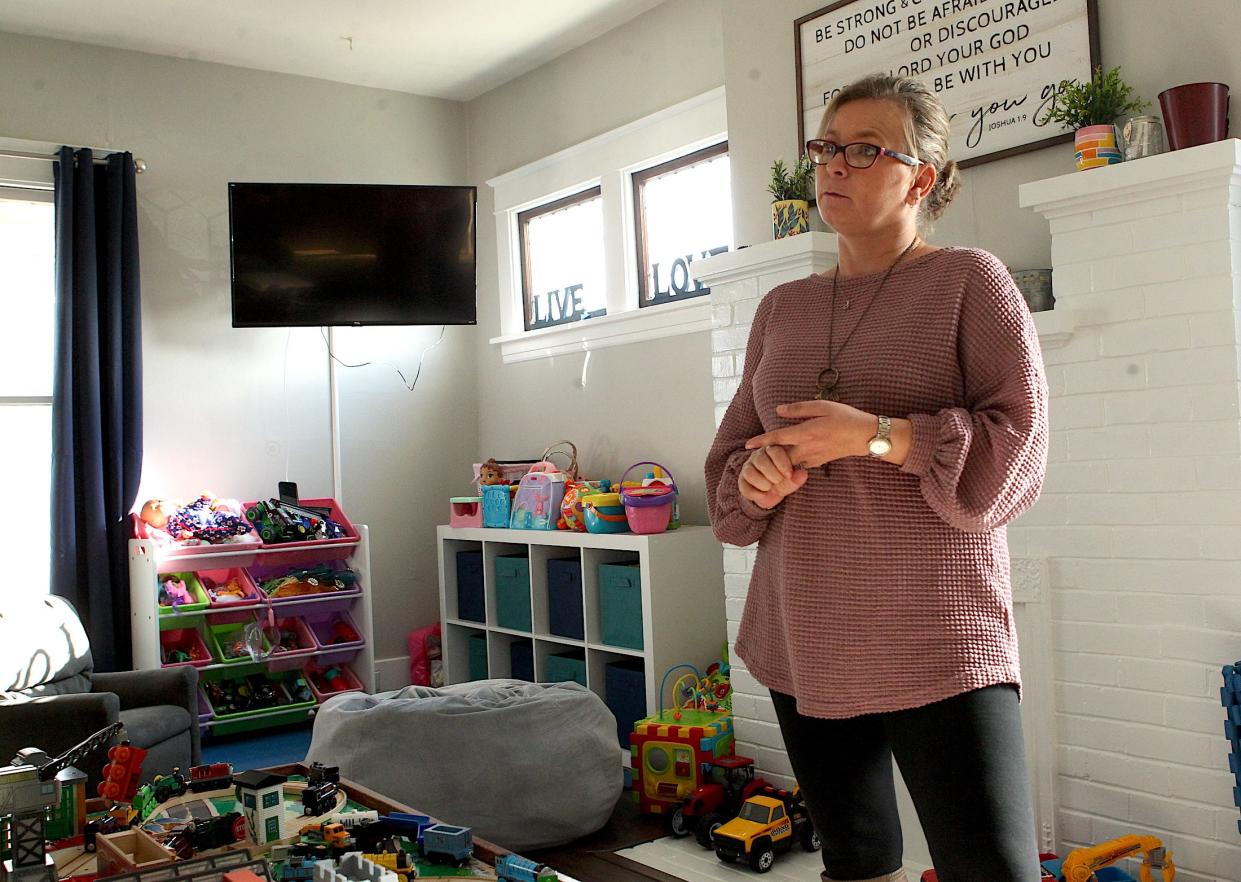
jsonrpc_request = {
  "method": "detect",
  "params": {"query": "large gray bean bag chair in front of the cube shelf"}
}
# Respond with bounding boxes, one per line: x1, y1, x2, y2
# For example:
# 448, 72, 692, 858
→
307, 680, 624, 851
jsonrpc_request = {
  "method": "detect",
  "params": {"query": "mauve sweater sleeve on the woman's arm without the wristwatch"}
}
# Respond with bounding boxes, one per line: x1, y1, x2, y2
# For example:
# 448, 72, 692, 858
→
706, 294, 776, 546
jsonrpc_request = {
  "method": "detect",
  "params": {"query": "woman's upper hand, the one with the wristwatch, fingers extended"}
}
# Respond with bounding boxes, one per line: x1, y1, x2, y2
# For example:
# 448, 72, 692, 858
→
746, 401, 879, 469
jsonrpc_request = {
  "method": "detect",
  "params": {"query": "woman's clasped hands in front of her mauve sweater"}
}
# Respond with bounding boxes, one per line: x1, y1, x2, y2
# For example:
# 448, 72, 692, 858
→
737, 401, 876, 509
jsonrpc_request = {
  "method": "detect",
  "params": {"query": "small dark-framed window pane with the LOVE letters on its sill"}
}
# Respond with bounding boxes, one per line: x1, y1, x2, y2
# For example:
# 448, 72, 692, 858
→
632, 141, 732, 306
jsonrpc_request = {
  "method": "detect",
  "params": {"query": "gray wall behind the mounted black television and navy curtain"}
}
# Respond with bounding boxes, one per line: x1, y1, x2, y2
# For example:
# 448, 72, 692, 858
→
0, 33, 478, 657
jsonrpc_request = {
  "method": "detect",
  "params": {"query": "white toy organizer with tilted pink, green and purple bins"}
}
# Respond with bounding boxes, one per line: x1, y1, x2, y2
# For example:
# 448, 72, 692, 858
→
129, 525, 375, 734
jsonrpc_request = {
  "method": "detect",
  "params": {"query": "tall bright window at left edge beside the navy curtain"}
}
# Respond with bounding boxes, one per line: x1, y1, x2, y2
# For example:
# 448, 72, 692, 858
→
0, 188, 56, 595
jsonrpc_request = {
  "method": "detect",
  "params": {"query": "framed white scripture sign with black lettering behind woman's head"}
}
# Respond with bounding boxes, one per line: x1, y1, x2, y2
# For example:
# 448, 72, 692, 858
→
793, 0, 1098, 166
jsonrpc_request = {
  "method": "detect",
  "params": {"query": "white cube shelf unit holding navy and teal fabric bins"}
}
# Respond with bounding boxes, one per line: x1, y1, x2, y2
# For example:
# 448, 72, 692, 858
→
437, 526, 727, 741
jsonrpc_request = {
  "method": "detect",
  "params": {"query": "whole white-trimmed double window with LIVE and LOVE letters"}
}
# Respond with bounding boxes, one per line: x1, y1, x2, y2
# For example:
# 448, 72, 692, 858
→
480, 87, 732, 363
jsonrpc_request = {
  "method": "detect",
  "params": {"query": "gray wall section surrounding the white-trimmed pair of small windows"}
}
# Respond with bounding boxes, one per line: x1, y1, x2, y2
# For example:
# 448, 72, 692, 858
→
468, 0, 724, 523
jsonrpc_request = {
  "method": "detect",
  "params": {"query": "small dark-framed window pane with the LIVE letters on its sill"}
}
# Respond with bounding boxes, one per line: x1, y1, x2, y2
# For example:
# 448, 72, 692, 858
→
517, 187, 608, 331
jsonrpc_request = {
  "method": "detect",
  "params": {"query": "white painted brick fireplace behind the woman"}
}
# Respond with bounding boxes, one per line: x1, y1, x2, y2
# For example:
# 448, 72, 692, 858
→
695, 140, 1241, 882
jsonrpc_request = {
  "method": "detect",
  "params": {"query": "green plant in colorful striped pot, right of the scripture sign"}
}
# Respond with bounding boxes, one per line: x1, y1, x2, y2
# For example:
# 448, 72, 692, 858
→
1042, 66, 1150, 170
